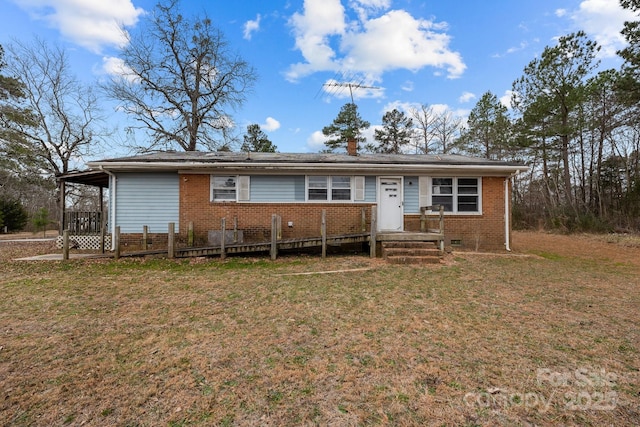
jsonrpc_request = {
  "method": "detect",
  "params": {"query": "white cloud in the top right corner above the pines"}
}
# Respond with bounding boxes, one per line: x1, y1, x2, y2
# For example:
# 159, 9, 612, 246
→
571, 0, 637, 57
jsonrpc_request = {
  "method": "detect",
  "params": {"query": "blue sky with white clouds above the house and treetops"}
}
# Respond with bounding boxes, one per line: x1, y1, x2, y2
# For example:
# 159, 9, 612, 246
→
0, 0, 636, 155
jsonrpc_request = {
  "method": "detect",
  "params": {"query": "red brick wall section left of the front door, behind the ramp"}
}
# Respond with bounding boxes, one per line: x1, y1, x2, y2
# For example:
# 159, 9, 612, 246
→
180, 174, 371, 244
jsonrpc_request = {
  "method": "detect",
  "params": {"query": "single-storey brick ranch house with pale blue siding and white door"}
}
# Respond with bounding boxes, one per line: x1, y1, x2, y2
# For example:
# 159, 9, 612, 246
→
61, 152, 527, 251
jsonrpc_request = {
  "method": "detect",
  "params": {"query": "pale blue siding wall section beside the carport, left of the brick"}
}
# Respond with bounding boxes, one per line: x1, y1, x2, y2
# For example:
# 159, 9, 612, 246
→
115, 173, 180, 233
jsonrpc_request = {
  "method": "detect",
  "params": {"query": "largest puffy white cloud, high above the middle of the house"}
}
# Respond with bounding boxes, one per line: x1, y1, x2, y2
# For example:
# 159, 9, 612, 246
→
287, 0, 466, 81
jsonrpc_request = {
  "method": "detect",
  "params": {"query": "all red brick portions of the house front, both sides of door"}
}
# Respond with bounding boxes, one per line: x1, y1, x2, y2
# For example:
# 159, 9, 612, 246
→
129, 174, 505, 251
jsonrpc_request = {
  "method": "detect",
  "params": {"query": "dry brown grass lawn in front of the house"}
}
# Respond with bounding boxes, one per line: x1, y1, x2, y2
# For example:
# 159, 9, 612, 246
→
0, 233, 640, 426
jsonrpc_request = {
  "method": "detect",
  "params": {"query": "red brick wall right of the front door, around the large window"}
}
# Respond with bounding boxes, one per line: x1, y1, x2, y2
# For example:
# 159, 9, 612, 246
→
405, 177, 505, 251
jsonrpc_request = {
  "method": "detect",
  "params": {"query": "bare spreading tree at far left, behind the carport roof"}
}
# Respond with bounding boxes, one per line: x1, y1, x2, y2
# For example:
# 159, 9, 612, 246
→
4, 39, 102, 175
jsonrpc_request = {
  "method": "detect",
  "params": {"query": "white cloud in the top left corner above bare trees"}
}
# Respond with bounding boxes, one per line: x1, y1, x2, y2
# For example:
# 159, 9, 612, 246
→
15, 0, 144, 53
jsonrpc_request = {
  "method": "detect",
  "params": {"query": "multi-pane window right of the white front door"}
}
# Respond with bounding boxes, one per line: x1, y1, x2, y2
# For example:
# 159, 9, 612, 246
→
431, 177, 480, 213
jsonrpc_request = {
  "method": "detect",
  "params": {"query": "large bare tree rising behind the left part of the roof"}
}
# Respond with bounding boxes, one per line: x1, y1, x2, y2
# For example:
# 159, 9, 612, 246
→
104, 0, 256, 151
